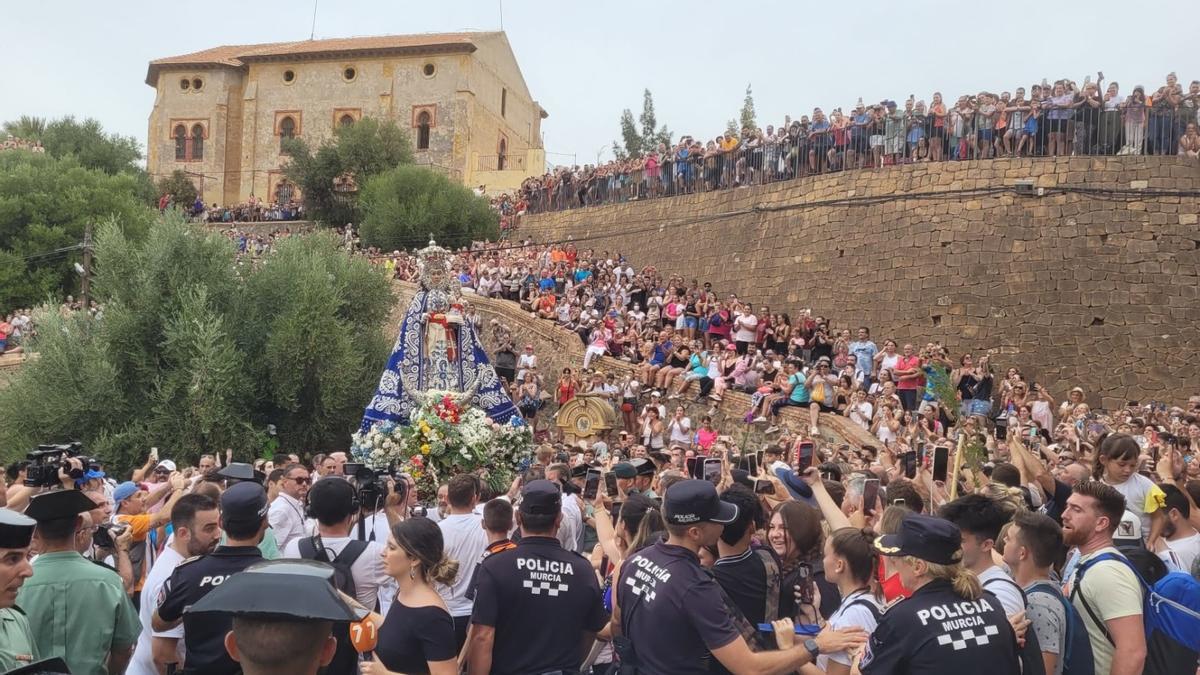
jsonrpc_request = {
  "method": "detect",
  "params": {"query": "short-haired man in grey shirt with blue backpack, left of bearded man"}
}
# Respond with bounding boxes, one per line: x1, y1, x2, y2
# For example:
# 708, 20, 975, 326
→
1004, 510, 1094, 675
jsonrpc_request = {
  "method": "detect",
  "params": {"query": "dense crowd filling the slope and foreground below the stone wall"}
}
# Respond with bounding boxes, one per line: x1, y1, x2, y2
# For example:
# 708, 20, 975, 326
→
0, 228, 1200, 675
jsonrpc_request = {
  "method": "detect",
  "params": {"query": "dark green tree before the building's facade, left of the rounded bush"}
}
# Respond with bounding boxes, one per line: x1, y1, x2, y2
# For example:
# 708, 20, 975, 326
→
284, 118, 413, 227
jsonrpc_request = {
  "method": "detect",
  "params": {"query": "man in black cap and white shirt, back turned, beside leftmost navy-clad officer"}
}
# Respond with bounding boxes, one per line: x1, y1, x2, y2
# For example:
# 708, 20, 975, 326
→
283, 478, 389, 608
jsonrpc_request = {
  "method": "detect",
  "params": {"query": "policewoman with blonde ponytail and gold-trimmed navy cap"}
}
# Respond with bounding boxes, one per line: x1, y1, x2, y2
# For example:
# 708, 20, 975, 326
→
860, 514, 1021, 675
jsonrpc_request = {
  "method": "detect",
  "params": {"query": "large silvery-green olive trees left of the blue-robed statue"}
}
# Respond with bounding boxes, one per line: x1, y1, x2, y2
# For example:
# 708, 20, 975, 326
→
0, 214, 392, 471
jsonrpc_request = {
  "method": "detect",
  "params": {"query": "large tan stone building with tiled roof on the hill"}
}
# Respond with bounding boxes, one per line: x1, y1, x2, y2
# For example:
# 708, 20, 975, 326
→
145, 32, 547, 204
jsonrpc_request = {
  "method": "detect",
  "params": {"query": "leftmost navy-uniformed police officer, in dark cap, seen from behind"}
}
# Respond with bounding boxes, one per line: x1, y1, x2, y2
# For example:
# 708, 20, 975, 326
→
152, 482, 268, 675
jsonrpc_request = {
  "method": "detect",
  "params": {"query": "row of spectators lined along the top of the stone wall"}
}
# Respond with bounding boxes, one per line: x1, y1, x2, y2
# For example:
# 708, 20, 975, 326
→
499, 73, 1200, 213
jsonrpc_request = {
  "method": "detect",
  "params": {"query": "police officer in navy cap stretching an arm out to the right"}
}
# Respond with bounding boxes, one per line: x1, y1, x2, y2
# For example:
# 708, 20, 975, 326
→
613, 479, 866, 675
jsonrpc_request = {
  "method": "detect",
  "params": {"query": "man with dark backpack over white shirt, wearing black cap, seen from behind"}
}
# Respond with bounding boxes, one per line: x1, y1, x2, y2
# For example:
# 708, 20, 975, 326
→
283, 478, 388, 675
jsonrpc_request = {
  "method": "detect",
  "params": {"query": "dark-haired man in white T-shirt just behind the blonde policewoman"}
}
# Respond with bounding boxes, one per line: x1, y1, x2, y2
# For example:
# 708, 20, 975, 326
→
938, 495, 1025, 616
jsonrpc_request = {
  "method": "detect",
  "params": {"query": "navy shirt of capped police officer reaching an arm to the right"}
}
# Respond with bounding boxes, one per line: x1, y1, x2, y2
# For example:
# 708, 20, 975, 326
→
617, 542, 740, 675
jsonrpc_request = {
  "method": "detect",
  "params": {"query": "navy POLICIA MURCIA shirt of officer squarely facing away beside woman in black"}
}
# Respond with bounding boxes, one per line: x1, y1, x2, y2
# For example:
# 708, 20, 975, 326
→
470, 536, 608, 675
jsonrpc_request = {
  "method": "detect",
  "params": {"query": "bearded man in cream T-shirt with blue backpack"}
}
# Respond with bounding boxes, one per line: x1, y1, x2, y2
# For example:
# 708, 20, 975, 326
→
1062, 480, 1146, 675
